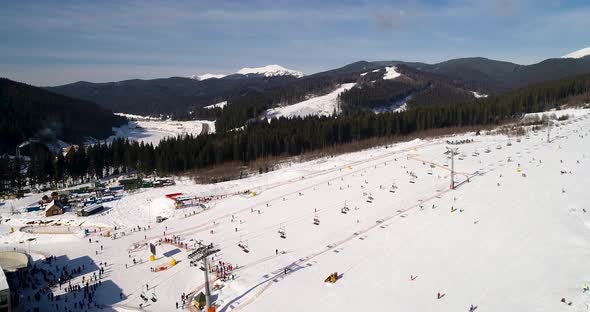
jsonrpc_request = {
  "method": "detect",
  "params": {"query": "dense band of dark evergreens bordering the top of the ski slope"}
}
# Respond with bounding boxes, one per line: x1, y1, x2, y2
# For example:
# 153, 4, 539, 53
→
0, 74, 590, 191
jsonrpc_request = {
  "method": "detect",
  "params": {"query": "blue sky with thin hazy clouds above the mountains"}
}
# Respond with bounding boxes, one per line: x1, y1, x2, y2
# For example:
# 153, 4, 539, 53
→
0, 0, 590, 86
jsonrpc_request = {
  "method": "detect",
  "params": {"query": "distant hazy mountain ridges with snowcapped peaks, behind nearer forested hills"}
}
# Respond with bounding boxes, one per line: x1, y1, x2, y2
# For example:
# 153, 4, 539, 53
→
47, 49, 590, 118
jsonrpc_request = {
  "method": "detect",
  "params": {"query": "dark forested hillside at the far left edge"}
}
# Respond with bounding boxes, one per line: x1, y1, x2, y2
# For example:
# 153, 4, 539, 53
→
0, 78, 126, 154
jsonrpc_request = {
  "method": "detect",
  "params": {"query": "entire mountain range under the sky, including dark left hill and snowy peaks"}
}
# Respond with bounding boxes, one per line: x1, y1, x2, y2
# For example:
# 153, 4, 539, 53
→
0, 49, 590, 152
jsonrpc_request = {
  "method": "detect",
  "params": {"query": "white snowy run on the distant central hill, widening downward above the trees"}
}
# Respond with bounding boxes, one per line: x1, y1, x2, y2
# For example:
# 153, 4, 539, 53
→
265, 83, 355, 120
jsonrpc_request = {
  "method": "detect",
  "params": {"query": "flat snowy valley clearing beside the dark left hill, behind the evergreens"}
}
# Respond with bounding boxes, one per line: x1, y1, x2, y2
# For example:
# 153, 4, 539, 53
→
107, 119, 215, 145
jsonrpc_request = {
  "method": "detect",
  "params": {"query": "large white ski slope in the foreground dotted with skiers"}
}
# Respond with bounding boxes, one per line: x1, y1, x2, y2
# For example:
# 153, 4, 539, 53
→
0, 110, 590, 312
